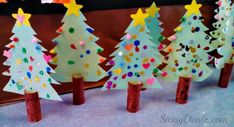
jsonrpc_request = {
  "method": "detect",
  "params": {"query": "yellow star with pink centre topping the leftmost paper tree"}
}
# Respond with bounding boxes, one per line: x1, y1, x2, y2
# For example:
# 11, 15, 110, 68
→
12, 8, 31, 26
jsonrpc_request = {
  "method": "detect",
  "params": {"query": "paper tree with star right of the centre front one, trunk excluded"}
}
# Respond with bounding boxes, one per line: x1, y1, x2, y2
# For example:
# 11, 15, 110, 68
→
164, 0, 214, 81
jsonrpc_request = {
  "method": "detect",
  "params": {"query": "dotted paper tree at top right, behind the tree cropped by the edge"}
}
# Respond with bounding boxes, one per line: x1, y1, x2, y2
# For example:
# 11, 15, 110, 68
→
210, 0, 231, 48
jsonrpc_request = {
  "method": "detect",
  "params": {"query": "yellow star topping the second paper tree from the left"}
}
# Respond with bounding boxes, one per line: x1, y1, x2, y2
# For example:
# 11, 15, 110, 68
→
64, 0, 83, 16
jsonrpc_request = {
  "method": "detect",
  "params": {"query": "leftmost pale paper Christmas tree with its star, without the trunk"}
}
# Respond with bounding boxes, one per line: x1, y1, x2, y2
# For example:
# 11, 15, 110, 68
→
3, 8, 61, 100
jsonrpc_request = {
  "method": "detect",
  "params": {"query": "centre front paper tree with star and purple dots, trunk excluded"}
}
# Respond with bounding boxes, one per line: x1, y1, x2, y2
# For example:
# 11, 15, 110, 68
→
103, 9, 165, 90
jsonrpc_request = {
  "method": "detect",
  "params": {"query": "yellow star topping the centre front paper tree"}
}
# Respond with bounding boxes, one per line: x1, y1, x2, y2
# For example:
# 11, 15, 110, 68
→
131, 9, 149, 26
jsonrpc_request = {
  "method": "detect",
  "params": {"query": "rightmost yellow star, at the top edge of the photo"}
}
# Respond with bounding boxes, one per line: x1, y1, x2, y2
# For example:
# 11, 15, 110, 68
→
185, 0, 202, 16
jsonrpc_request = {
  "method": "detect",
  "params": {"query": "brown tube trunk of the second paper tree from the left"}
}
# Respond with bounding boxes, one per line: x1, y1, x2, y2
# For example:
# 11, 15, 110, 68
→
72, 74, 85, 105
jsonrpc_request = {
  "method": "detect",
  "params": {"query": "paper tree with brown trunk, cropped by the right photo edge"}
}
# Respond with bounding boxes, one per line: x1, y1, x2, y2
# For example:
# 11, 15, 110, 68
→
215, 5, 234, 88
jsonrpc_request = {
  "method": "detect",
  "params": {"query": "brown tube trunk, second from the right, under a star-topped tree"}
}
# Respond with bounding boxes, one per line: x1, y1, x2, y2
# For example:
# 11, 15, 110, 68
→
175, 77, 191, 104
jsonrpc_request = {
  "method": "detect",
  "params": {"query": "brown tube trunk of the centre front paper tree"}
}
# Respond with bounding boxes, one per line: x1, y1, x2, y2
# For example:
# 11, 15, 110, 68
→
127, 82, 143, 113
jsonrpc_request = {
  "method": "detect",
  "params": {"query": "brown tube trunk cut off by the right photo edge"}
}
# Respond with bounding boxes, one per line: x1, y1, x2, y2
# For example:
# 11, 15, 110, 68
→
218, 63, 233, 88
